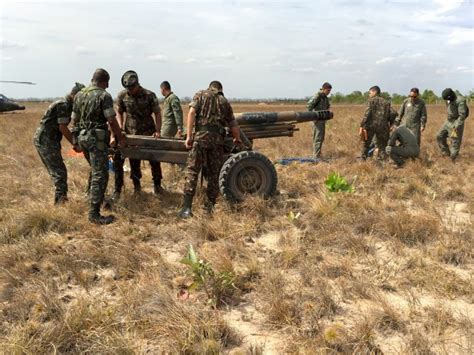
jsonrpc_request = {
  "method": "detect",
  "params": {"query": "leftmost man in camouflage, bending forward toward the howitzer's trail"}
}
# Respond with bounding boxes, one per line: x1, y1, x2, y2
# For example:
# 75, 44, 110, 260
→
34, 83, 85, 205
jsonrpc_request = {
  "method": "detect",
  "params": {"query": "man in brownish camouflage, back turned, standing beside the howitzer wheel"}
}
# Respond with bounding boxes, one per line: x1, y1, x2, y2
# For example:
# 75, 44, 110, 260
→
178, 81, 242, 218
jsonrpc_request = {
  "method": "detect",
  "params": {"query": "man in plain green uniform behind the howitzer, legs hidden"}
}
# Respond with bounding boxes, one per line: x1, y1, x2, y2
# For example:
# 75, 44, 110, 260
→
160, 81, 183, 138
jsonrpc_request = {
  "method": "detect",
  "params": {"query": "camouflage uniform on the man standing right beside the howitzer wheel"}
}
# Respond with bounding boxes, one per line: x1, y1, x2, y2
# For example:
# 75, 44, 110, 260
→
184, 89, 237, 204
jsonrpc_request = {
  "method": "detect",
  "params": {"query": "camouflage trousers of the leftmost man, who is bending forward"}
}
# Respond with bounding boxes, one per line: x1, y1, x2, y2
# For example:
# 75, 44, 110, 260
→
34, 137, 67, 197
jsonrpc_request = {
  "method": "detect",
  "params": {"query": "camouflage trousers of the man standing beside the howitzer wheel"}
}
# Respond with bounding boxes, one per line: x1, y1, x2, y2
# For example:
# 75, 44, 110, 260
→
184, 140, 224, 203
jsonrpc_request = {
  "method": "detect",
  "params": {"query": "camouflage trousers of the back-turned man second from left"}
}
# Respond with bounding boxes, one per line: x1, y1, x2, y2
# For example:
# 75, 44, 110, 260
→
78, 130, 109, 205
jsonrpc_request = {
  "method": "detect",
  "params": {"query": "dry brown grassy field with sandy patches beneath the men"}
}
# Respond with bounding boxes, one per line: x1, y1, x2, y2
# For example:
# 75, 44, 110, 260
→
0, 104, 474, 354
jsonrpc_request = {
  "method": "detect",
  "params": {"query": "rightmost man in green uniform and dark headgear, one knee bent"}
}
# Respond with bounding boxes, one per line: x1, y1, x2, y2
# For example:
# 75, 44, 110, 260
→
436, 88, 469, 161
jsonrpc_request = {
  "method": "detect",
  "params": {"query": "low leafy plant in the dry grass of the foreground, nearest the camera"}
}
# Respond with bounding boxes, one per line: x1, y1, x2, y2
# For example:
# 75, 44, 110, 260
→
181, 244, 237, 306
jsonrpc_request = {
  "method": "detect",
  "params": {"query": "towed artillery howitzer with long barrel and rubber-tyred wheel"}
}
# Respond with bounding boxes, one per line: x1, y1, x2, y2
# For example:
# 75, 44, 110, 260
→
121, 111, 333, 201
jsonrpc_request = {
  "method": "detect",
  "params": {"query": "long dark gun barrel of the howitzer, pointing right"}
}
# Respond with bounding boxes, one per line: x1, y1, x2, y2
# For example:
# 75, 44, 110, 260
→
234, 110, 333, 126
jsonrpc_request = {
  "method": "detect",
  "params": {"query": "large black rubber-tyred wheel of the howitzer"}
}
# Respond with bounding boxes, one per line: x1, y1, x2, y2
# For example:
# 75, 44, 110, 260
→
219, 151, 278, 202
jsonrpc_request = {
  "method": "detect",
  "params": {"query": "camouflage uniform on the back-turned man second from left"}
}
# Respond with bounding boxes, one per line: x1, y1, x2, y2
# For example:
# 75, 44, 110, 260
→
72, 85, 115, 217
